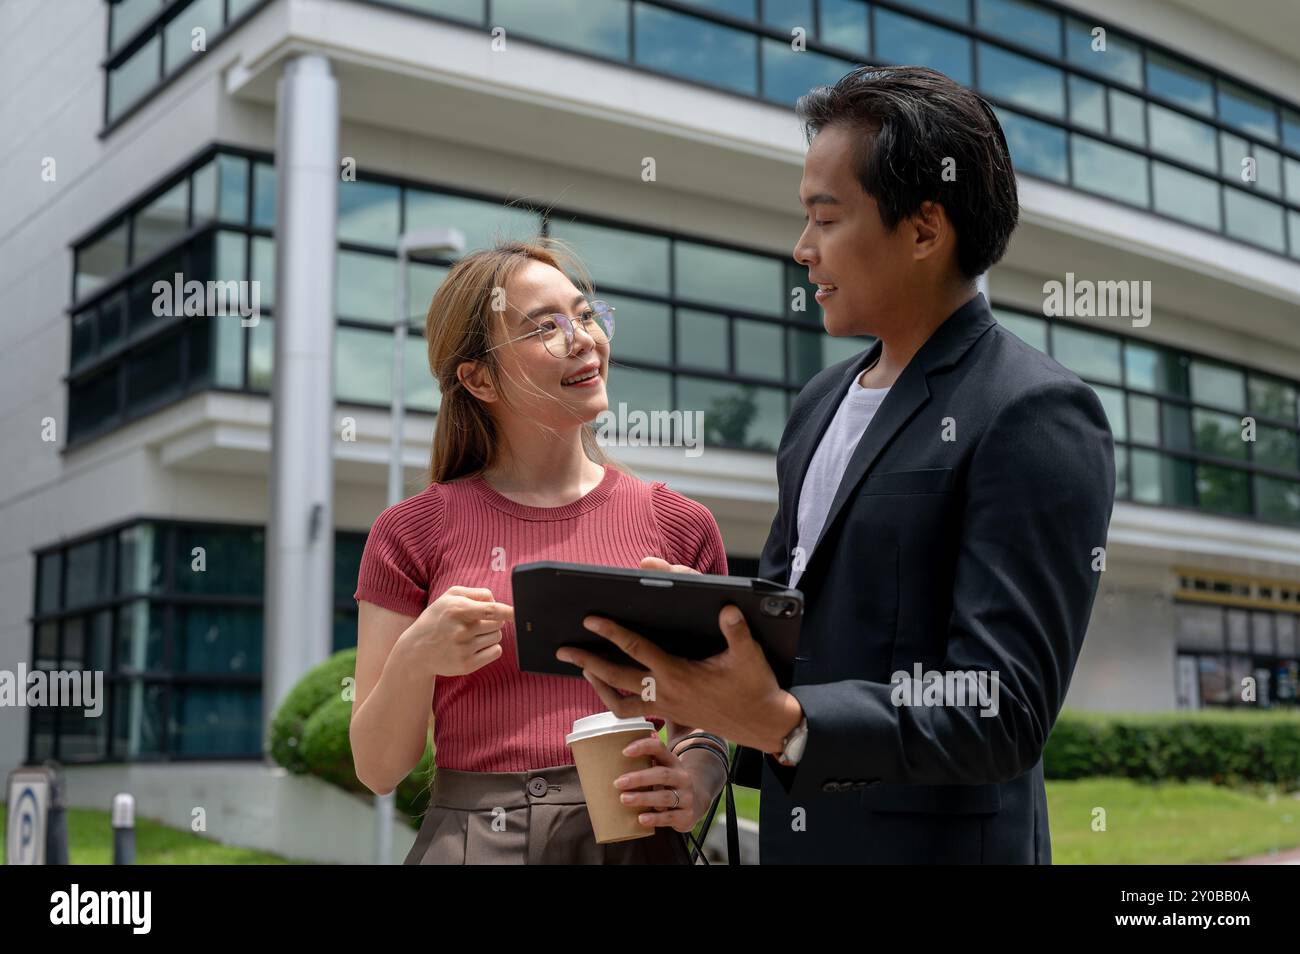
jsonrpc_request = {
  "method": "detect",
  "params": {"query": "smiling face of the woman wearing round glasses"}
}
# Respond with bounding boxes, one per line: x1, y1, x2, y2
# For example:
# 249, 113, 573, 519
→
493, 260, 610, 426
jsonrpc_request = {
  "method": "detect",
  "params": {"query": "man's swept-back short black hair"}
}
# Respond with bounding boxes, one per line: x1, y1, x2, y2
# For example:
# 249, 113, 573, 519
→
797, 66, 1021, 278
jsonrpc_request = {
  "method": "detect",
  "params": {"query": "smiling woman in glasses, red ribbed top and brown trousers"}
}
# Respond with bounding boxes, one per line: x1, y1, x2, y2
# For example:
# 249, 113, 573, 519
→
351, 240, 727, 864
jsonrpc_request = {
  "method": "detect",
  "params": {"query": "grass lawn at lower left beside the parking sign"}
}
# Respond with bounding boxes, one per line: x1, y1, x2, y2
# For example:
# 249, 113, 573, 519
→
0, 808, 309, 864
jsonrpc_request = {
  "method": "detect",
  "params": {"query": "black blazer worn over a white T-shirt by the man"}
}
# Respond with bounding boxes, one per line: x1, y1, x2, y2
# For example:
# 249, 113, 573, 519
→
737, 295, 1115, 863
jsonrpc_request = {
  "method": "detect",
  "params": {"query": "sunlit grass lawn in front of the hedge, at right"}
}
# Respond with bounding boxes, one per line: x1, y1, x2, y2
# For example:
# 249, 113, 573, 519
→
736, 779, 1300, 864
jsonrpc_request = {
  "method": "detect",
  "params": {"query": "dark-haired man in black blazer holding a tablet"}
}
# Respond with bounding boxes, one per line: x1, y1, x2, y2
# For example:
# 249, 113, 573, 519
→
560, 68, 1114, 863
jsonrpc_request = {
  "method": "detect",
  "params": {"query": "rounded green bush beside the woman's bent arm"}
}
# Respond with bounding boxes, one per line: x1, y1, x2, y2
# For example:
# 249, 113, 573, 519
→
270, 649, 433, 827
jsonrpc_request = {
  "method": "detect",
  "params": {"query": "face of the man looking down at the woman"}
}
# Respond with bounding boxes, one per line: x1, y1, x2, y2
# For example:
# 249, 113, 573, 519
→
794, 126, 915, 337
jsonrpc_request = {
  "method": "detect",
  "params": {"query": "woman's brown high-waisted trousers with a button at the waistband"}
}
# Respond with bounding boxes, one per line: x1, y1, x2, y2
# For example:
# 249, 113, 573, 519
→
404, 766, 690, 864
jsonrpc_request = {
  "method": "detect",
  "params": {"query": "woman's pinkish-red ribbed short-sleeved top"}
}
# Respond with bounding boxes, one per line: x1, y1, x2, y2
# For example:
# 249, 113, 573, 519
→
354, 467, 727, 772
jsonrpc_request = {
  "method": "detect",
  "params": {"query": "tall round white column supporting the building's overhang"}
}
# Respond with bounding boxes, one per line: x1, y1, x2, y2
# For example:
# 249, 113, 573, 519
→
263, 53, 339, 748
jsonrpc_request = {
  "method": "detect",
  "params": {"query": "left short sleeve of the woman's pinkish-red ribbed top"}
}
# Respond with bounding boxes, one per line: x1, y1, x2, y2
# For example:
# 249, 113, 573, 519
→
352, 485, 442, 616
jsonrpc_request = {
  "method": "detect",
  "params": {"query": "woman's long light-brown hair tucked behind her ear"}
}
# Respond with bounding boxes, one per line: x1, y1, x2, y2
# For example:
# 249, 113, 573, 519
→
424, 238, 614, 483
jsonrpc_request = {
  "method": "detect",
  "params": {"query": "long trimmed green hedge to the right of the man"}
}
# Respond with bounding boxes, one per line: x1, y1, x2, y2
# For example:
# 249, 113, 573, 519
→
1043, 710, 1300, 790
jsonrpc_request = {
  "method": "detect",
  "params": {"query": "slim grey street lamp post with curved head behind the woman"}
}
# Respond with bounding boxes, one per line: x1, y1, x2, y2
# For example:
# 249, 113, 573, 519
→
374, 229, 465, 864
